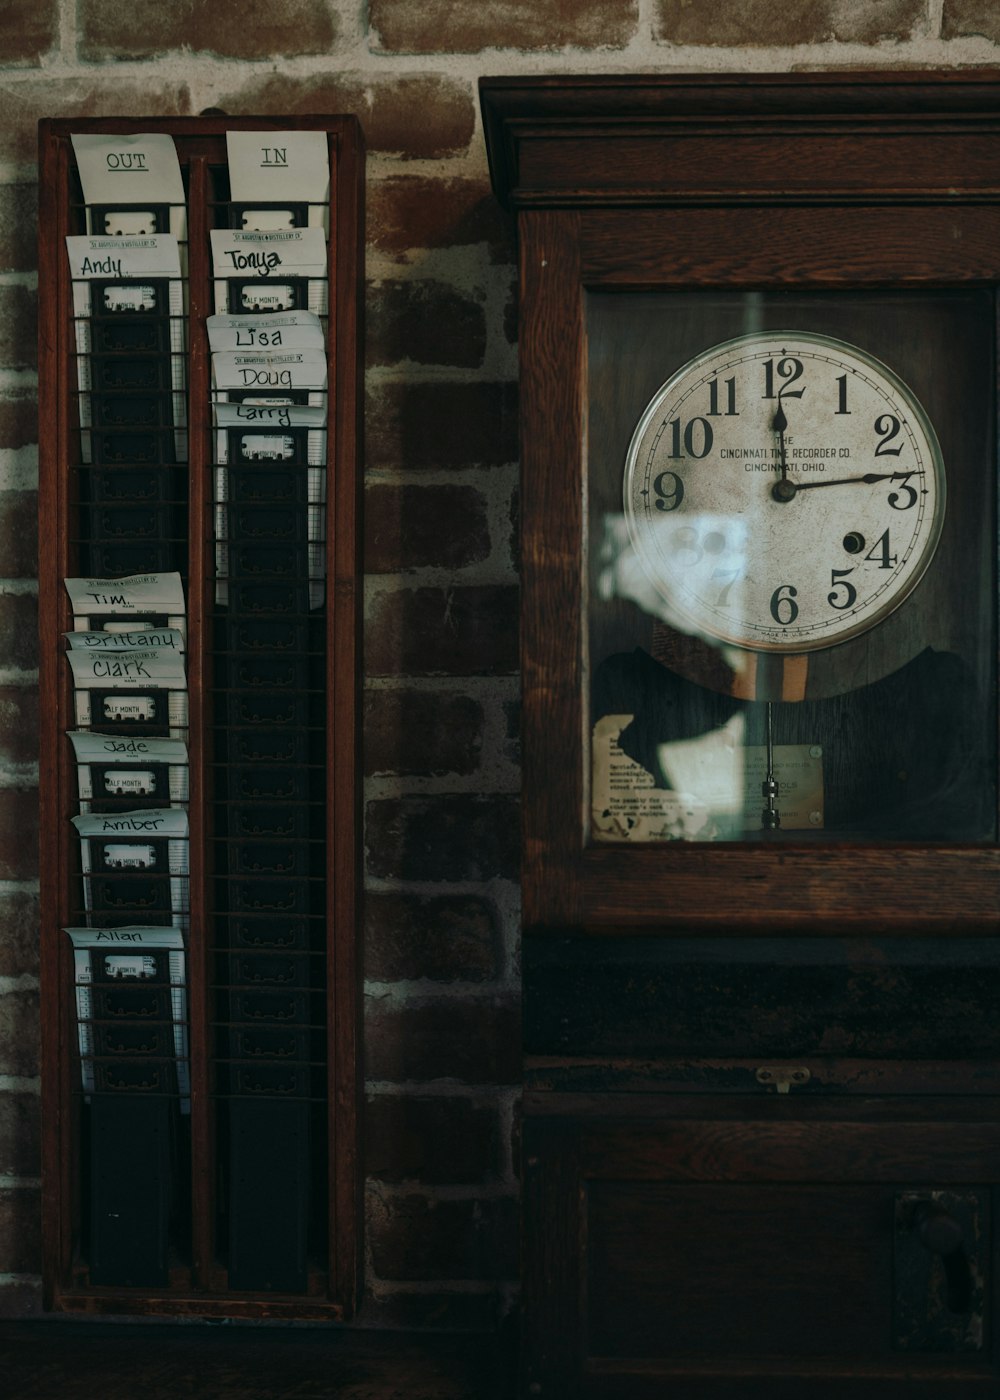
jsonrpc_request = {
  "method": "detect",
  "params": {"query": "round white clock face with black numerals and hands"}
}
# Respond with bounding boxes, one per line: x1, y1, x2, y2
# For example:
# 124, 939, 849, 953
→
623, 330, 945, 652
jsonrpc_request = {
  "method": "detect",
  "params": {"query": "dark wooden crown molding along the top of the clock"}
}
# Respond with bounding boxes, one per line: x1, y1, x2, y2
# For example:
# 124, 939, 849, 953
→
479, 69, 1000, 210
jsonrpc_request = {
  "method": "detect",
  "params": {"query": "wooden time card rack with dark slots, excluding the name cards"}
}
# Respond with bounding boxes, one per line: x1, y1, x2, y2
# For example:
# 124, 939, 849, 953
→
39, 115, 364, 1320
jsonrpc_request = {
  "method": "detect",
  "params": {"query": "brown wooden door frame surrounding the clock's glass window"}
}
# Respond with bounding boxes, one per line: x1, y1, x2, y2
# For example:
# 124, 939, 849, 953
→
513, 88, 1000, 934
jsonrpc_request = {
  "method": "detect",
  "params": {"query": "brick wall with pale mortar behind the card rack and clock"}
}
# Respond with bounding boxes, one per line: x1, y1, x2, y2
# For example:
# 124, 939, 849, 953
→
0, 0, 1000, 1327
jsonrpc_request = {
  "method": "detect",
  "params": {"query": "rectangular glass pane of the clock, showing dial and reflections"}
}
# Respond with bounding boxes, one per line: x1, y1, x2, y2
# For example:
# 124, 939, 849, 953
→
585, 290, 996, 843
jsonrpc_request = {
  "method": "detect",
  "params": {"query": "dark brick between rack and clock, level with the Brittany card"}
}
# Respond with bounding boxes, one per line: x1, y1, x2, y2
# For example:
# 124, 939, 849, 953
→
366, 585, 518, 676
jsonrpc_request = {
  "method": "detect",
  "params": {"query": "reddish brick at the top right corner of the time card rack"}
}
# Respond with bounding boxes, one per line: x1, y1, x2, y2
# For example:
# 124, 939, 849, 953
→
218, 73, 476, 160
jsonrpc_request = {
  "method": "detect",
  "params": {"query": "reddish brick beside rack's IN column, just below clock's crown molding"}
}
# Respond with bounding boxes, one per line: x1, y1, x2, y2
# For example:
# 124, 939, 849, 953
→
366, 175, 517, 265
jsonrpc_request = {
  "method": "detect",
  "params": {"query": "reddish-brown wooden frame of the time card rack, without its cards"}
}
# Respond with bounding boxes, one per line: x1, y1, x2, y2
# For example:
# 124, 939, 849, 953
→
39, 116, 364, 1320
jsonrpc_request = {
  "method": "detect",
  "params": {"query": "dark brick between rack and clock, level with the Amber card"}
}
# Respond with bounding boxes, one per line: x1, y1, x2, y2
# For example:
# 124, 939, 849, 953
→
367, 792, 520, 881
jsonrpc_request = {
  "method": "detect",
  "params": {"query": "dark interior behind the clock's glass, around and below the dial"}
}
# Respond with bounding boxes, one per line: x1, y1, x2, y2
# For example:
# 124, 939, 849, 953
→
585, 290, 997, 841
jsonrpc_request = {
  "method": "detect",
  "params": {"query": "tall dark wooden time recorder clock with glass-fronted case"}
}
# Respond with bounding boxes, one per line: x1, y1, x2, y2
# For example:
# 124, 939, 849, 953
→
482, 73, 1000, 1400
